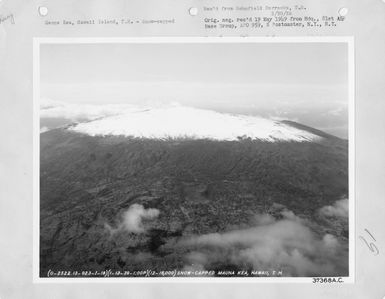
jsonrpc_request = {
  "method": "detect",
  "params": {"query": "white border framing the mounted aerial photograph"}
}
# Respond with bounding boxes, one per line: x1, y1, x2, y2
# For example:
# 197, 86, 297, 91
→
32, 36, 356, 283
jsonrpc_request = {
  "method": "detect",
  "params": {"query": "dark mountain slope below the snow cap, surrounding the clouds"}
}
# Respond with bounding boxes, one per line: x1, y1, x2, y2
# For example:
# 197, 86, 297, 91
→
40, 127, 348, 276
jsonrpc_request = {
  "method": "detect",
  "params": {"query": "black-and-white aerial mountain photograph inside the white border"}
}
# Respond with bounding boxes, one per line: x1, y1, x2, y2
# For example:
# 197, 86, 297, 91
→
35, 38, 353, 280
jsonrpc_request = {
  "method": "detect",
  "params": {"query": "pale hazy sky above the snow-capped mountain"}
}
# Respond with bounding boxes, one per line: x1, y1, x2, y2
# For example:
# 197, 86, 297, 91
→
40, 43, 348, 137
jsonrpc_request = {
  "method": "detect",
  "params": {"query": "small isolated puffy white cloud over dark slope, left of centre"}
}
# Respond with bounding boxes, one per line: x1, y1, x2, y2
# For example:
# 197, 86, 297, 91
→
106, 204, 159, 234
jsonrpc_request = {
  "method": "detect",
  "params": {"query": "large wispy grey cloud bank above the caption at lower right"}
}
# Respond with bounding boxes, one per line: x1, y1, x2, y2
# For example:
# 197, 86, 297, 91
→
178, 210, 348, 276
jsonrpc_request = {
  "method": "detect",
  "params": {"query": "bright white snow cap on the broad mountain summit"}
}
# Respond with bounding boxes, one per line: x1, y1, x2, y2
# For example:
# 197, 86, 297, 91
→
70, 106, 322, 142
